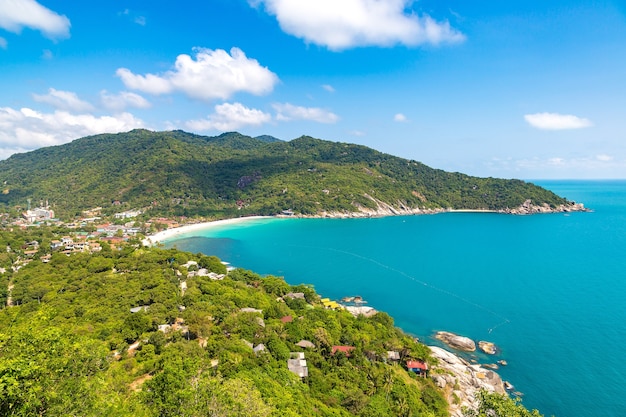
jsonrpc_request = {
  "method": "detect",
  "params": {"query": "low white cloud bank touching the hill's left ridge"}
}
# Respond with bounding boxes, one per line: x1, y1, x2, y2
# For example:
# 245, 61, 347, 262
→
0, 107, 144, 157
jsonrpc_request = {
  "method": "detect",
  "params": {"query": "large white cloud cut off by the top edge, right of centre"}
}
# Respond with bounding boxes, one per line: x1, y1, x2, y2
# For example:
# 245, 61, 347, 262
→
249, 0, 465, 50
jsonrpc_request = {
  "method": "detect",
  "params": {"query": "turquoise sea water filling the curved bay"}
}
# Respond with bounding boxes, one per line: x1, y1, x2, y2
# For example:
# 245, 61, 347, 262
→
168, 181, 626, 416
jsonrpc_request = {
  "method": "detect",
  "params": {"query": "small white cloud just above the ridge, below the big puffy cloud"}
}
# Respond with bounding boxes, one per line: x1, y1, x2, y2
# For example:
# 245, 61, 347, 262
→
185, 103, 272, 132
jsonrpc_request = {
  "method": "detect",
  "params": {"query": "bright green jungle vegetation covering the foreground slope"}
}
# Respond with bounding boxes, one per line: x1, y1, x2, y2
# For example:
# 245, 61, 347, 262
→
0, 227, 539, 417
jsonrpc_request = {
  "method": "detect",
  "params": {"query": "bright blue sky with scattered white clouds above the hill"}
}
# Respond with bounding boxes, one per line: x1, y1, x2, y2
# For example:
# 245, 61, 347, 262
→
0, 0, 626, 179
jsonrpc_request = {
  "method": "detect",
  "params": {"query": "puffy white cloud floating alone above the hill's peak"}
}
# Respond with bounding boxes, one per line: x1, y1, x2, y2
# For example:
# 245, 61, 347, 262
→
117, 48, 278, 101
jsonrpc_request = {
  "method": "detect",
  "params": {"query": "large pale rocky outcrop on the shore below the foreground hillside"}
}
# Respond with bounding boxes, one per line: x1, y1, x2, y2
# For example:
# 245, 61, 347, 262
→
429, 346, 506, 417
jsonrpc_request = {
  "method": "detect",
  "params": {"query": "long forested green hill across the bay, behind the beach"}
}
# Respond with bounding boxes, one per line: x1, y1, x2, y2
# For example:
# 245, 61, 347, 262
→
0, 130, 567, 218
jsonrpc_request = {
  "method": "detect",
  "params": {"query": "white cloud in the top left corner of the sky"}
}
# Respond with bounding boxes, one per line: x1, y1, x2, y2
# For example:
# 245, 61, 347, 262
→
0, 0, 71, 39
